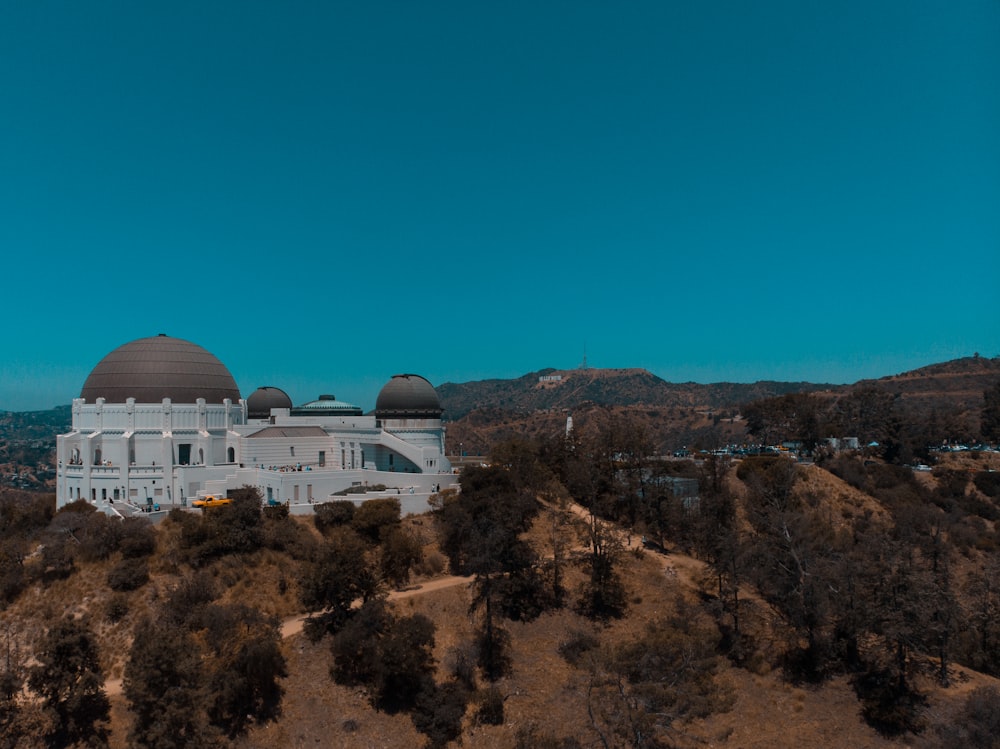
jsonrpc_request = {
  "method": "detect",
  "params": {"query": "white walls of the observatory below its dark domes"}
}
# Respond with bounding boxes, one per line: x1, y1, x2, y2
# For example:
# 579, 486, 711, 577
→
57, 398, 457, 512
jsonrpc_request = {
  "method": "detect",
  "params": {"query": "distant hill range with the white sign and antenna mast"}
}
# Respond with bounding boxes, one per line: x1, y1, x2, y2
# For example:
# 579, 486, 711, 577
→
437, 357, 1000, 454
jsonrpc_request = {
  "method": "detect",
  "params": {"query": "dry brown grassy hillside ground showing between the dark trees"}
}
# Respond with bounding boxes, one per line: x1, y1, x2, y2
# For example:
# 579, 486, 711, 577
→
0, 454, 1000, 749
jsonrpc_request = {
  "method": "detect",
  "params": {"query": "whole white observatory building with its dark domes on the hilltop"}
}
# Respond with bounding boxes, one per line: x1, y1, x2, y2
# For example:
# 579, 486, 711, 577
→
56, 334, 457, 513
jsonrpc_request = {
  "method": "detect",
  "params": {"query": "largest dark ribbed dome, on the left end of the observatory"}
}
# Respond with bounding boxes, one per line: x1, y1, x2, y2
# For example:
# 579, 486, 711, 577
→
80, 333, 240, 403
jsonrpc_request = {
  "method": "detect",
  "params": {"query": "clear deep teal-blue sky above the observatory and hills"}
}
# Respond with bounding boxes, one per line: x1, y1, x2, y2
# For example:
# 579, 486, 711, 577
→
0, 0, 1000, 410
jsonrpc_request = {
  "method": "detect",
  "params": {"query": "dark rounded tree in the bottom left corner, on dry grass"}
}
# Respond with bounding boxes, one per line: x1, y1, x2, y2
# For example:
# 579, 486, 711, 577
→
28, 618, 111, 747
